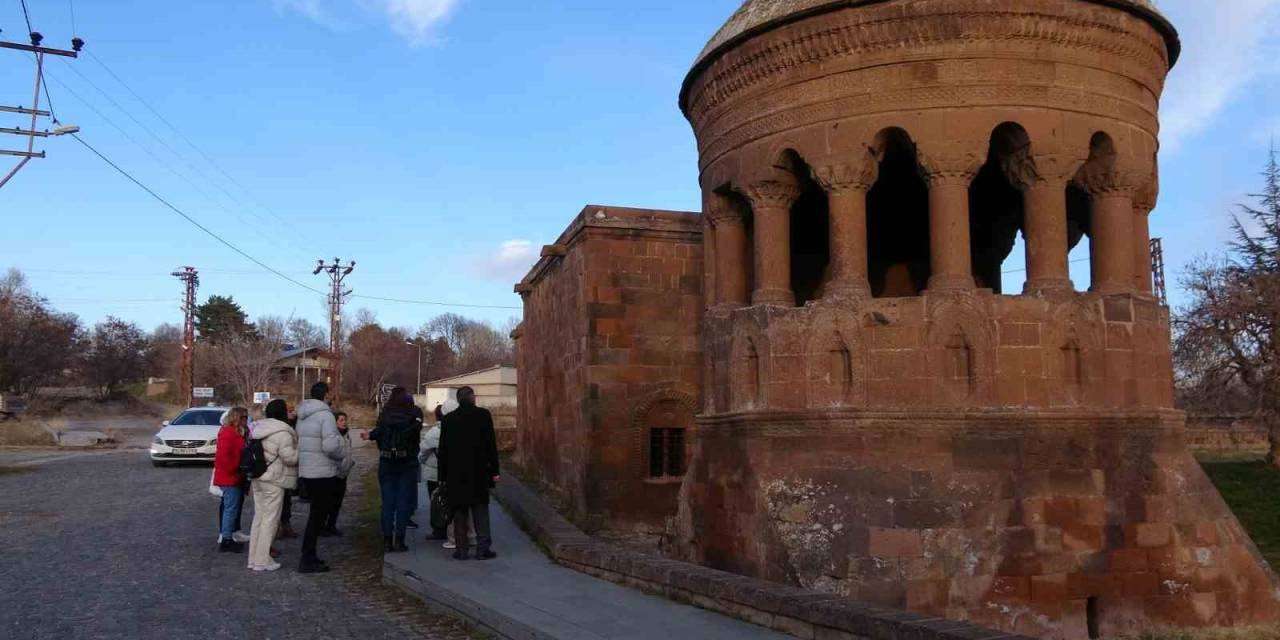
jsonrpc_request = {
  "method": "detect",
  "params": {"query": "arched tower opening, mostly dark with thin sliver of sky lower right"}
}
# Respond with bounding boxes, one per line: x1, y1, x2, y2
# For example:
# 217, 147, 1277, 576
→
969, 123, 1030, 293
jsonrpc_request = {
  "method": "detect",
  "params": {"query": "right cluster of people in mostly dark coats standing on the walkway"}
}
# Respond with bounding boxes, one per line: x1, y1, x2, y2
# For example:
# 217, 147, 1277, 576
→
367, 387, 499, 559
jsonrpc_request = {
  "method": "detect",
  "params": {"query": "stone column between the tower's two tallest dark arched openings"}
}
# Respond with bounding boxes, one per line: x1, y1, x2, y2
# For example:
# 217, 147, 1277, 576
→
919, 143, 986, 292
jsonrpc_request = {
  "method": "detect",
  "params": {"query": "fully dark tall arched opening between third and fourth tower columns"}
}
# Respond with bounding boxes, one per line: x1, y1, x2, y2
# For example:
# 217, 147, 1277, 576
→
867, 128, 931, 298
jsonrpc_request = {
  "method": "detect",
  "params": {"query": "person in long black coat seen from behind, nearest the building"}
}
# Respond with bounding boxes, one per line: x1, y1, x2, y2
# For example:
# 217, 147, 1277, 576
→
438, 387, 498, 559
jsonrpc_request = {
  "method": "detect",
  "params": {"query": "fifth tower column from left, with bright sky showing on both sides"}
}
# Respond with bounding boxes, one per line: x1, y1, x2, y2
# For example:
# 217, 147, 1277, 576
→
1010, 154, 1078, 294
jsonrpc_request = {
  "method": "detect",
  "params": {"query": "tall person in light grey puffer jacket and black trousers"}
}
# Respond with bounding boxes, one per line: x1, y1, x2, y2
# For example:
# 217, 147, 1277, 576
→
298, 383, 346, 573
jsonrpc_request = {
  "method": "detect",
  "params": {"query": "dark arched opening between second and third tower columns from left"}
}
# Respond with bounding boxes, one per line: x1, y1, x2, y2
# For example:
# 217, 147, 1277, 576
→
778, 151, 831, 306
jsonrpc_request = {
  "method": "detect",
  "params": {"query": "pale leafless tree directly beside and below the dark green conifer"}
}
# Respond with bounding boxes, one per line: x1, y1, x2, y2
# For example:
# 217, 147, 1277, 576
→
206, 317, 285, 402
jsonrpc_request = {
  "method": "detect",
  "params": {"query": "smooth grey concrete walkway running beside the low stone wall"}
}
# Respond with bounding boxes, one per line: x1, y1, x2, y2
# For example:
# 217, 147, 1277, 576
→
383, 499, 791, 640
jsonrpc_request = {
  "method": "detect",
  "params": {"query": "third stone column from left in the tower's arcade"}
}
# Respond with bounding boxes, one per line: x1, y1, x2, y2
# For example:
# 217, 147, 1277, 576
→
813, 152, 879, 300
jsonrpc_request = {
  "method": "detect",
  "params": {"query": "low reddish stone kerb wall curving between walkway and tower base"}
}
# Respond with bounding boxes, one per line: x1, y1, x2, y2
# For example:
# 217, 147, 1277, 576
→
494, 475, 1029, 640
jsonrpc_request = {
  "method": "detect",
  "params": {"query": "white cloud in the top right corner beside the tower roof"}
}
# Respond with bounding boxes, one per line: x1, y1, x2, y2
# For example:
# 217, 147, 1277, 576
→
1160, 0, 1280, 152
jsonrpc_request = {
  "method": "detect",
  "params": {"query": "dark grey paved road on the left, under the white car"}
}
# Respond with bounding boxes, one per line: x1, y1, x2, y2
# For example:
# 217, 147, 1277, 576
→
0, 449, 471, 640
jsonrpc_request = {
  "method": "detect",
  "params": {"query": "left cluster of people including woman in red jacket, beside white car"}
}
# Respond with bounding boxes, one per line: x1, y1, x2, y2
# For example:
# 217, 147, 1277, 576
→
212, 383, 355, 573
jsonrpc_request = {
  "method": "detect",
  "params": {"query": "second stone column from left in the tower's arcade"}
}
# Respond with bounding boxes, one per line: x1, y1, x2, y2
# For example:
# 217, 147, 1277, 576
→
744, 180, 800, 307
